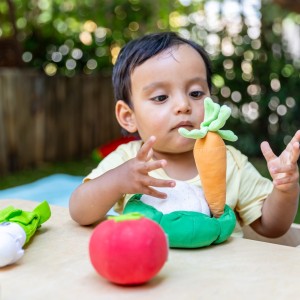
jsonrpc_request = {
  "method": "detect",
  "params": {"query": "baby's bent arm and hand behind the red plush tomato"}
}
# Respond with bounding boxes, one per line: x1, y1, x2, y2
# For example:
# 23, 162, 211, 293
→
69, 137, 175, 225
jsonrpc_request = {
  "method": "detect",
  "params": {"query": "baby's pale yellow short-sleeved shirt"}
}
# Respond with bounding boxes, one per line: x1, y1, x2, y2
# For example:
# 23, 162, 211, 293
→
84, 141, 273, 236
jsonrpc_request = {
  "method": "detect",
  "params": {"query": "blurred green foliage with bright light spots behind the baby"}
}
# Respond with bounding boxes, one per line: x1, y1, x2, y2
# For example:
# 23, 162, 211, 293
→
0, 0, 300, 156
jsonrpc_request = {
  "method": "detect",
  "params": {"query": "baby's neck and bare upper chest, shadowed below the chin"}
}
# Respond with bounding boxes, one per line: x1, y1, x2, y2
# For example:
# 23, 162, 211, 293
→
153, 151, 198, 180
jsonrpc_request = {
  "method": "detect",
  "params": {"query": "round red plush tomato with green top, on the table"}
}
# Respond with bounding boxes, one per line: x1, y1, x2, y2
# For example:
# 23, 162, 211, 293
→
89, 213, 168, 285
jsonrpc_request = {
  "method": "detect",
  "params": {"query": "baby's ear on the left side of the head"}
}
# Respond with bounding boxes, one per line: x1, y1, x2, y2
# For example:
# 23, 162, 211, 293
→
115, 100, 137, 133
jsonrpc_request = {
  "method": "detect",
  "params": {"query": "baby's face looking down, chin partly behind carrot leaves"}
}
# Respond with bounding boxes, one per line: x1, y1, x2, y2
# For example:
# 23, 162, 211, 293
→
123, 45, 210, 153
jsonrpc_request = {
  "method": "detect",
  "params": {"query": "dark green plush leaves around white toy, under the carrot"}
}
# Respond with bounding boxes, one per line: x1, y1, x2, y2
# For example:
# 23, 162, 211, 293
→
124, 194, 236, 248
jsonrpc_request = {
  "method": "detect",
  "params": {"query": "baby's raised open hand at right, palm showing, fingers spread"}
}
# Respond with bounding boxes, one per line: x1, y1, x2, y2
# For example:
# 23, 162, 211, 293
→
261, 130, 300, 192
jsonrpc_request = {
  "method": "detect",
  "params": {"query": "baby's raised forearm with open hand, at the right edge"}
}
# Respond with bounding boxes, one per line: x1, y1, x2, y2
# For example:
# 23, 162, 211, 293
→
251, 130, 300, 237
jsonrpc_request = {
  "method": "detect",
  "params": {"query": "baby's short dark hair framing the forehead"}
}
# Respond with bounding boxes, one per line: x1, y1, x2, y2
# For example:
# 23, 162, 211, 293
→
112, 32, 212, 105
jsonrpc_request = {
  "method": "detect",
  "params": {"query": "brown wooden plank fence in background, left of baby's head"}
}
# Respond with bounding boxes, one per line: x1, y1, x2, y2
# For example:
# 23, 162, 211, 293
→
0, 69, 120, 175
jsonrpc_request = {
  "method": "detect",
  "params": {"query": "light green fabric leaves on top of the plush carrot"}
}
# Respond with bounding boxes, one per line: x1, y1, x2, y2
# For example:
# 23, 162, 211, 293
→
178, 97, 238, 142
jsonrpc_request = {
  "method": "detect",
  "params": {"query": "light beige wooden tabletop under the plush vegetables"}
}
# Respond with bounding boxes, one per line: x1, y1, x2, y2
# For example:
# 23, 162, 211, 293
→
0, 200, 300, 300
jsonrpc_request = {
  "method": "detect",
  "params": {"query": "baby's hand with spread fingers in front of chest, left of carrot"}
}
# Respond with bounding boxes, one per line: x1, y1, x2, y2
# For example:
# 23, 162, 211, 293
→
123, 136, 176, 199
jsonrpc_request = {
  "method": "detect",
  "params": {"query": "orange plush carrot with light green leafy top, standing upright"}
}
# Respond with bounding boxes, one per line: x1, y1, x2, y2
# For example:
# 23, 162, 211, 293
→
179, 98, 237, 217
